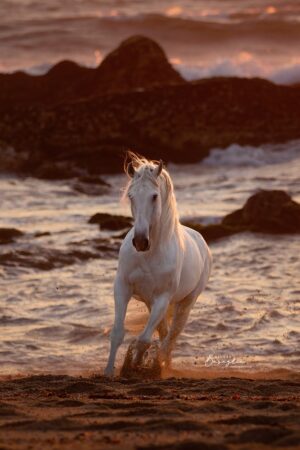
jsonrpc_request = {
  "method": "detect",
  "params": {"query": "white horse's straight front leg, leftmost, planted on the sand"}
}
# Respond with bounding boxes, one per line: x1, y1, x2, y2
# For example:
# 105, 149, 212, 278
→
104, 276, 131, 376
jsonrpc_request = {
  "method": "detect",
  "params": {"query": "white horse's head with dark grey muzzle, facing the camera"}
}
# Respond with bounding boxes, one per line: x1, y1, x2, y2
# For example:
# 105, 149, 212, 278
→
126, 161, 163, 252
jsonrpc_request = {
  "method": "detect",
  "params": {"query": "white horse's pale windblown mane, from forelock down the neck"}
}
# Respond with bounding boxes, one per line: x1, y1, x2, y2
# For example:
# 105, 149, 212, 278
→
123, 151, 183, 245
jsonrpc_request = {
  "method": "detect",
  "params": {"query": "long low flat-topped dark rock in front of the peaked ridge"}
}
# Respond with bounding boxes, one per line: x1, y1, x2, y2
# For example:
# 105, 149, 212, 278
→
0, 78, 300, 178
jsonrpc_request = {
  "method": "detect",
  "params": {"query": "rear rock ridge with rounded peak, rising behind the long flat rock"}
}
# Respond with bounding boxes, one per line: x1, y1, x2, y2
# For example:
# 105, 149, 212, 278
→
0, 36, 184, 106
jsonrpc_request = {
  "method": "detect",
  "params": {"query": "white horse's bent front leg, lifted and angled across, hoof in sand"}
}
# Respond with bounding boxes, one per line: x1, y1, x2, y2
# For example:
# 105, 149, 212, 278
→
134, 294, 170, 365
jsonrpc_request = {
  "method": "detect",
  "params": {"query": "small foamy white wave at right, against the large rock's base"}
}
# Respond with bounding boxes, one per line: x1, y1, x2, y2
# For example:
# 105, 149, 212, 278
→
202, 140, 300, 167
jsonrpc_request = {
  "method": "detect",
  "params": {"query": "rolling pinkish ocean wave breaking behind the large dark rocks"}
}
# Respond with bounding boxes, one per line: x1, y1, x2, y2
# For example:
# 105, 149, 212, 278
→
0, 11, 300, 78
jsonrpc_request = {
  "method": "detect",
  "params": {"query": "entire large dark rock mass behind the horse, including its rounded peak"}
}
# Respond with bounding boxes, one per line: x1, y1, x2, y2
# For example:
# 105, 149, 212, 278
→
0, 37, 300, 178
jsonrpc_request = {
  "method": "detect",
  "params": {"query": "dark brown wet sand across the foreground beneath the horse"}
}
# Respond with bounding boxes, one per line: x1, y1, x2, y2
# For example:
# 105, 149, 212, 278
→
0, 373, 300, 450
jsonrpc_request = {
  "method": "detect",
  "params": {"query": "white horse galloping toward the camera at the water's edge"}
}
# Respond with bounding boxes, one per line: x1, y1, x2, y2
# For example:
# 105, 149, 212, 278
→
105, 153, 212, 376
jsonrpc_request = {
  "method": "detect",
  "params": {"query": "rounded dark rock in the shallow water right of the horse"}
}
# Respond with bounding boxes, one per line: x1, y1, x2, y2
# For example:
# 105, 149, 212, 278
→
222, 190, 300, 233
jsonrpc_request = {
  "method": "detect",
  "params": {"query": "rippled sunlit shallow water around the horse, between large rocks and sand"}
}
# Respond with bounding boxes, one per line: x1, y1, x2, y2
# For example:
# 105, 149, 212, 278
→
0, 142, 300, 374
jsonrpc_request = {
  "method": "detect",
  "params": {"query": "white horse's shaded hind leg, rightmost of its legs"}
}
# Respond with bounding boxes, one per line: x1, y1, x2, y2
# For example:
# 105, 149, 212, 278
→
161, 292, 198, 367
